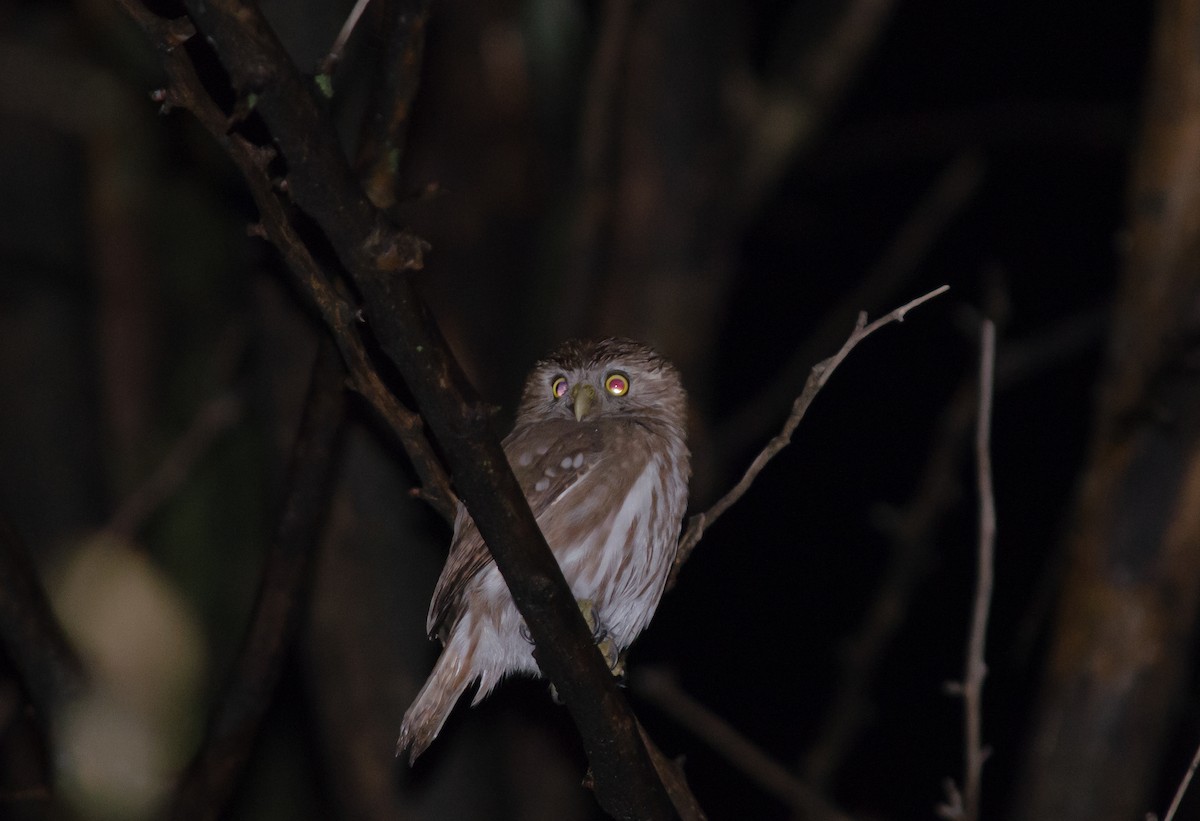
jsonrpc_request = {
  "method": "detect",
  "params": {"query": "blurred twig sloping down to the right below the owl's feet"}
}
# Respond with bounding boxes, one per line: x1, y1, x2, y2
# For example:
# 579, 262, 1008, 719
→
631, 667, 850, 821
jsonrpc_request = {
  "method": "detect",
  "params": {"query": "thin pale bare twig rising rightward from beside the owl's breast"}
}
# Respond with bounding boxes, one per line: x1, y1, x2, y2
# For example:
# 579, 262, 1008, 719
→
667, 286, 950, 589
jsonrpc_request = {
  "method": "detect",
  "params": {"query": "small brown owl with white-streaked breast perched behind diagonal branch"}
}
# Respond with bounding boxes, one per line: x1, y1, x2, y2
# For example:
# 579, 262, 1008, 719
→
397, 338, 690, 761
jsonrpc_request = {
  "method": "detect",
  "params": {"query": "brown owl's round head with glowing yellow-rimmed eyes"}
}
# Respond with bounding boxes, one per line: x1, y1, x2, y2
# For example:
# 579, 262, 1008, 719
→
517, 338, 686, 427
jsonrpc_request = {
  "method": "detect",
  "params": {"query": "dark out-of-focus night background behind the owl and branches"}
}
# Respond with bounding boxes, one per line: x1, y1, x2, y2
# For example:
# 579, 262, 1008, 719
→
0, 0, 1200, 820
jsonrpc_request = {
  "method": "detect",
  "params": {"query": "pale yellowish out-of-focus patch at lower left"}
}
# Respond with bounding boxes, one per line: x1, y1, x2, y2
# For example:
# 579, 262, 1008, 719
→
52, 533, 205, 819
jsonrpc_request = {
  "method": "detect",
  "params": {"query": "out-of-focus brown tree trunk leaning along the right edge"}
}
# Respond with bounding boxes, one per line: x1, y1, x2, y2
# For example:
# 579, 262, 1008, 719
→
1013, 0, 1200, 821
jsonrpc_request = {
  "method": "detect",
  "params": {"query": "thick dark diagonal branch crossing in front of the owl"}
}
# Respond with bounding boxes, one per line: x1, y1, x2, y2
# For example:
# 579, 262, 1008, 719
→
121, 0, 672, 819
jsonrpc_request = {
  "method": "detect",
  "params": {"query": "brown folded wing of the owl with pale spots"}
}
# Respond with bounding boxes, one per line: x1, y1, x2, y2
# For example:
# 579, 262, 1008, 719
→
426, 419, 604, 636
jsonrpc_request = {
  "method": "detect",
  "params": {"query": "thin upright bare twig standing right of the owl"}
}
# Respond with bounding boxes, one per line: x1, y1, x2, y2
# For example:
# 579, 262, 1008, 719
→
938, 319, 996, 821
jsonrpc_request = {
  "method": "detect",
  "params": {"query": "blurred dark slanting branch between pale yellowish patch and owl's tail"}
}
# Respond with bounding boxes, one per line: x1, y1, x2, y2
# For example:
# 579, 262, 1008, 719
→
170, 341, 346, 821
